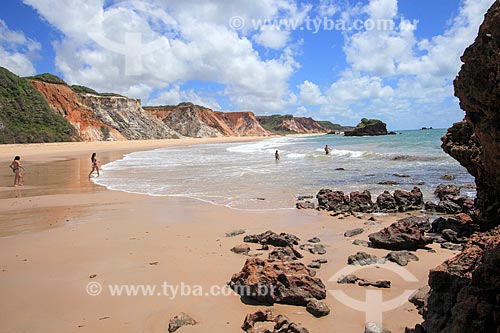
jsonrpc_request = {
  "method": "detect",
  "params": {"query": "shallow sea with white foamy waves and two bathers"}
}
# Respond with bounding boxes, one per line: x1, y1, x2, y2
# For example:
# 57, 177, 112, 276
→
93, 129, 475, 210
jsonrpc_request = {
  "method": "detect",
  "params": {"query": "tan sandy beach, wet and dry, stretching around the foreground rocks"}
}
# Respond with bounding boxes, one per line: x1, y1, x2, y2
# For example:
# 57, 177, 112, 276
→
0, 138, 453, 333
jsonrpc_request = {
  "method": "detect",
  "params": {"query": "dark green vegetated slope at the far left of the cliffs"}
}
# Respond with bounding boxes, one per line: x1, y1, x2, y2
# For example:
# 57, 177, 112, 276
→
0, 67, 78, 143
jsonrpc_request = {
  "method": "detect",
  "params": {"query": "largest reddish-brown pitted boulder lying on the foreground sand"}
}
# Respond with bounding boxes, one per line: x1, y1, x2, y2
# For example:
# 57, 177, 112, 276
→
229, 258, 326, 306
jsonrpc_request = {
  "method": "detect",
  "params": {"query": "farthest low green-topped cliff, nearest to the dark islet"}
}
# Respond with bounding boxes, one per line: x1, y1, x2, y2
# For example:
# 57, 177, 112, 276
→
257, 115, 329, 134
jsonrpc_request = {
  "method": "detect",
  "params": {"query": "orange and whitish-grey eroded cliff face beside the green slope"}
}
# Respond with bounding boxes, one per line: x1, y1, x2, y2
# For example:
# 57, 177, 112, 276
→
31, 80, 178, 141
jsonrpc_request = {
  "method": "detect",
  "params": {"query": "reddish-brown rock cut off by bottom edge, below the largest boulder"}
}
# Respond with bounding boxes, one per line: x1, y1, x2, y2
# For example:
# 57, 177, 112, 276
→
241, 310, 309, 333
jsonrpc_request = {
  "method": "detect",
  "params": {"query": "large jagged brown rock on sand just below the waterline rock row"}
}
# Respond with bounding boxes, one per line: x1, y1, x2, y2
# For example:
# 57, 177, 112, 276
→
368, 217, 432, 251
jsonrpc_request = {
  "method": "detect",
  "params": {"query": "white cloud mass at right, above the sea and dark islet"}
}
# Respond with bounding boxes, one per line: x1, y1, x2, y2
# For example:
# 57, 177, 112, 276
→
306, 0, 493, 128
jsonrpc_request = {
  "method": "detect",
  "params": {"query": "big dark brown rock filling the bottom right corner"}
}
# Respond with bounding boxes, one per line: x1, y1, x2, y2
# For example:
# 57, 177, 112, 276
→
423, 226, 500, 333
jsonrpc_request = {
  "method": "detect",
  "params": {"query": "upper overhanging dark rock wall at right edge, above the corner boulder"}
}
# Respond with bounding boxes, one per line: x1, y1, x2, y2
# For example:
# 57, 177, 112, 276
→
443, 1, 500, 228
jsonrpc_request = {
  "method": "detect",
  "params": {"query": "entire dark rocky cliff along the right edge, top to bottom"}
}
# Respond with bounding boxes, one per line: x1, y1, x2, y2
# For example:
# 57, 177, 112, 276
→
419, 1, 500, 333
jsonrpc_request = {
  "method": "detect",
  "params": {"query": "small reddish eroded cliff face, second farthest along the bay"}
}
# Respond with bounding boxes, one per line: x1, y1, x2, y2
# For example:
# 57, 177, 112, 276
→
215, 112, 274, 136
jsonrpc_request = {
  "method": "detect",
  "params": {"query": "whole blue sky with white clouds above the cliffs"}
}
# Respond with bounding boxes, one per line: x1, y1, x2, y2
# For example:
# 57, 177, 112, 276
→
0, 0, 494, 130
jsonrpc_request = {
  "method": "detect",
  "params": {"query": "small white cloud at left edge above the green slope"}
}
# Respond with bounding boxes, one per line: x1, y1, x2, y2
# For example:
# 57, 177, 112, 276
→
0, 19, 41, 76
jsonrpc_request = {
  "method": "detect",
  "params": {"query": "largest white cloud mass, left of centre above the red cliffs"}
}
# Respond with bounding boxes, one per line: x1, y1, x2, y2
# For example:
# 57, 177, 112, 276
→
24, 0, 300, 109
